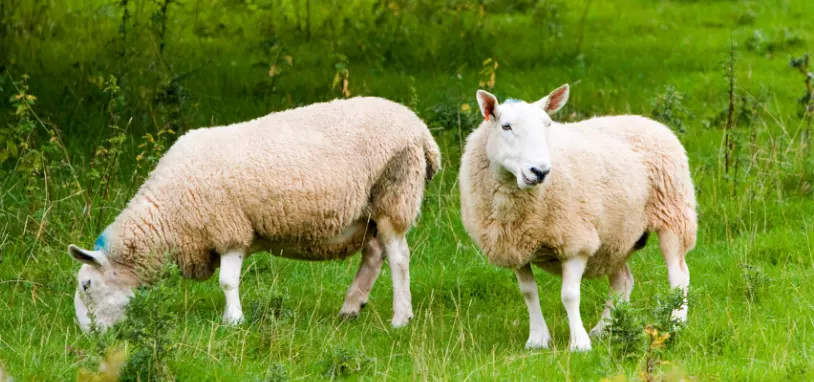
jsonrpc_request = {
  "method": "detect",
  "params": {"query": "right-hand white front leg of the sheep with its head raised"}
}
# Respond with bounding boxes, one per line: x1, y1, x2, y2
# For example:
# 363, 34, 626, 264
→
561, 255, 591, 351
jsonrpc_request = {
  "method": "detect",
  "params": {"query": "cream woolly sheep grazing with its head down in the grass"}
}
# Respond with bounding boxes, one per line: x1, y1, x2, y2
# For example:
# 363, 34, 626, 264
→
68, 97, 441, 330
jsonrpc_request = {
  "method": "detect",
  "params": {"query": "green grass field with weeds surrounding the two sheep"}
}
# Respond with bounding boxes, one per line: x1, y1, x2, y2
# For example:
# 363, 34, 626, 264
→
0, 0, 814, 381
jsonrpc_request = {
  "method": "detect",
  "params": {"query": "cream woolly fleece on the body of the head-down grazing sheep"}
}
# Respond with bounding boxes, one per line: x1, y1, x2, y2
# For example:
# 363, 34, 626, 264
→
97, 97, 441, 281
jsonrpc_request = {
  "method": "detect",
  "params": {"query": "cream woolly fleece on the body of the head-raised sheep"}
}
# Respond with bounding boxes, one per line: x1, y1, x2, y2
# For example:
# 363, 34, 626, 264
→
460, 116, 697, 277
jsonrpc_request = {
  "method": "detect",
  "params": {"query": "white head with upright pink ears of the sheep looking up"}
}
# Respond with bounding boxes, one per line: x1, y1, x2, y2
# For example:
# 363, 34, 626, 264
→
477, 85, 568, 189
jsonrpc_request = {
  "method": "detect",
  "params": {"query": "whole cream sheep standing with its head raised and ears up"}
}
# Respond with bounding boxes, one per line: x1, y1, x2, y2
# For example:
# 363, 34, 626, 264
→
460, 85, 697, 350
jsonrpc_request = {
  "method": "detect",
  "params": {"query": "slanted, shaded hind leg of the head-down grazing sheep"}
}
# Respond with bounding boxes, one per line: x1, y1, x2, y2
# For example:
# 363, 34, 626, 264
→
339, 238, 384, 319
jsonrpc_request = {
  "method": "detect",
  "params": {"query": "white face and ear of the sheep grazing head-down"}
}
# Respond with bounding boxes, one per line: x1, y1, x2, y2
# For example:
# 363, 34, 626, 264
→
68, 244, 136, 332
